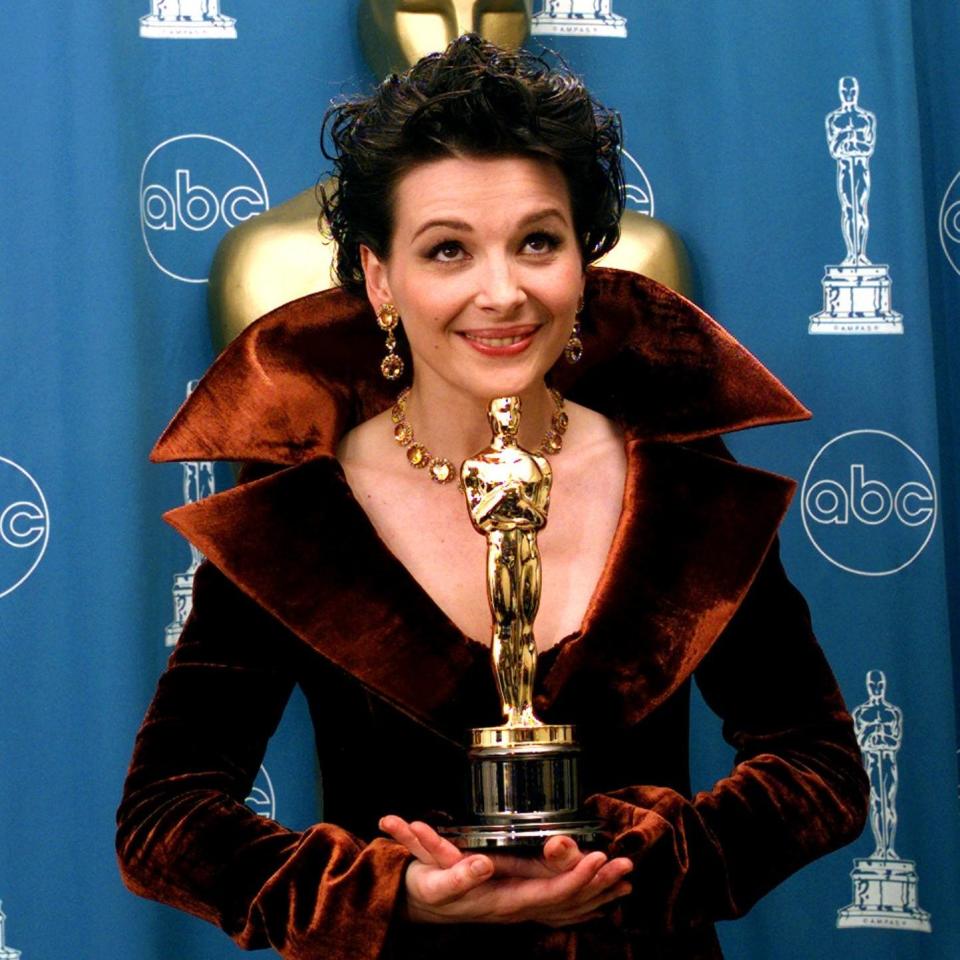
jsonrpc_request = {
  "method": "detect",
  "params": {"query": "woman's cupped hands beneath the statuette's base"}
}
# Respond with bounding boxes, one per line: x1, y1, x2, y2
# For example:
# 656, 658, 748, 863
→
380, 816, 633, 927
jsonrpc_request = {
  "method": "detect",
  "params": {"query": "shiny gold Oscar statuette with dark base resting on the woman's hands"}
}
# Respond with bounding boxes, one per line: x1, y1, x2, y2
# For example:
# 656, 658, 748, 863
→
440, 397, 600, 851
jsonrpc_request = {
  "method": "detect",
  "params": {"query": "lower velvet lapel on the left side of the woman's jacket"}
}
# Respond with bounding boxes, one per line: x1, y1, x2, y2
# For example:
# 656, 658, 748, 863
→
164, 457, 499, 743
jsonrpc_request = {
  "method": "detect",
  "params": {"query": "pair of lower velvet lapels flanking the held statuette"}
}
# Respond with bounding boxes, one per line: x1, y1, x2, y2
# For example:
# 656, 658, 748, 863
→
166, 440, 793, 740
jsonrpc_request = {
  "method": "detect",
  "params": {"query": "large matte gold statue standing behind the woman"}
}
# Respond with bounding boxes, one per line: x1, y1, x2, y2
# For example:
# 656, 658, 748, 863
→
208, 0, 692, 350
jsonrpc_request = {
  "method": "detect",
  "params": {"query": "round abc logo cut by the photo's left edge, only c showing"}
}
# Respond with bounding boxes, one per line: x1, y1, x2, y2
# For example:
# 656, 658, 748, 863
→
0, 457, 50, 597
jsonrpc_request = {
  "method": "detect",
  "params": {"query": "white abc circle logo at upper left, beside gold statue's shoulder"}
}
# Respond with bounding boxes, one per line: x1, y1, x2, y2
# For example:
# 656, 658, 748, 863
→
140, 133, 270, 283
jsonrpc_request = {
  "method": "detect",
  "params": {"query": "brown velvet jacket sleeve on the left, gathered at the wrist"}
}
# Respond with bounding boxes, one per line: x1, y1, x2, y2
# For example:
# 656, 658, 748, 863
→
117, 561, 409, 960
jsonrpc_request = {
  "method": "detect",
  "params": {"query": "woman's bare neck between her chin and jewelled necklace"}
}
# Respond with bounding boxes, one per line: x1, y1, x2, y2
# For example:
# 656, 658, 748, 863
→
407, 377, 554, 465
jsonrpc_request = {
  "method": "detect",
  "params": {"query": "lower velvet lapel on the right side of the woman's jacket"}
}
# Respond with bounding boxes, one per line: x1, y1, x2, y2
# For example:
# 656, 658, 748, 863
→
537, 440, 795, 725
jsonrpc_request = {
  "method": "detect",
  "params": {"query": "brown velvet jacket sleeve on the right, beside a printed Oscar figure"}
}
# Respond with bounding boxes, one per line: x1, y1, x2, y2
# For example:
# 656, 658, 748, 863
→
589, 544, 869, 934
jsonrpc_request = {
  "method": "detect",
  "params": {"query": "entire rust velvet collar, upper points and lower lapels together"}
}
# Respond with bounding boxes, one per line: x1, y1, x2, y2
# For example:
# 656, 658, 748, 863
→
153, 270, 809, 740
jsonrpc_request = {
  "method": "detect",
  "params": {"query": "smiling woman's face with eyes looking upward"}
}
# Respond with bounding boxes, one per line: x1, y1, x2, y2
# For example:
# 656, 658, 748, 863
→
361, 157, 584, 402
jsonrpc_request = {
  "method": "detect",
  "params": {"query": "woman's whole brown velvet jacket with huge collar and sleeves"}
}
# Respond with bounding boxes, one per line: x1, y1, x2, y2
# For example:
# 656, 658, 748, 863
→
118, 269, 868, 960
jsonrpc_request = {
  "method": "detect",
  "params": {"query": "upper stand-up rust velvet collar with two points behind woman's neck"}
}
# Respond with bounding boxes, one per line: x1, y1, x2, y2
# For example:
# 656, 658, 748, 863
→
151, 268, 809, 466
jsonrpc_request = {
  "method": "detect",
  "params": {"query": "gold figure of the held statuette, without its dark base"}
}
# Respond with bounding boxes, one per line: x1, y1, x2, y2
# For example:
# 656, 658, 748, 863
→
460, 397, 553, 727
